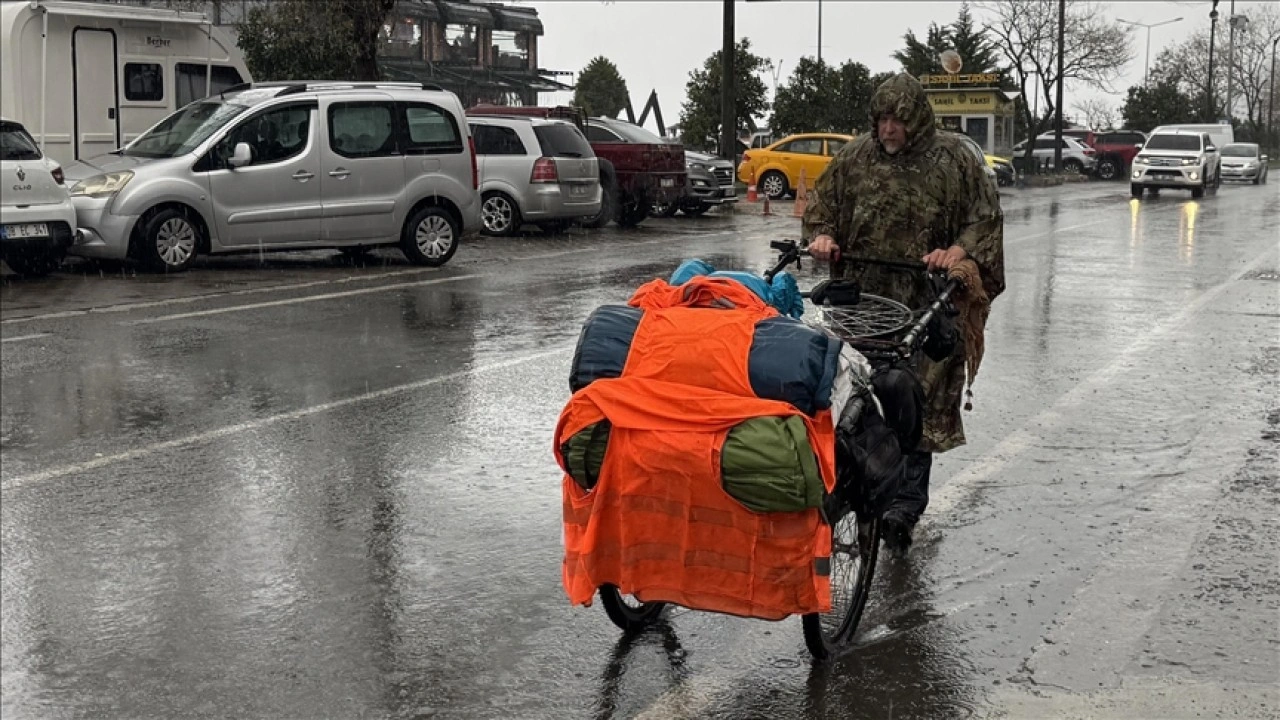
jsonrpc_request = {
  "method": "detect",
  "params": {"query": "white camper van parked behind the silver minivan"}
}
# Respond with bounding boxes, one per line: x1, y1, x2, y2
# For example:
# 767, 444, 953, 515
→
0, 0, 252, 165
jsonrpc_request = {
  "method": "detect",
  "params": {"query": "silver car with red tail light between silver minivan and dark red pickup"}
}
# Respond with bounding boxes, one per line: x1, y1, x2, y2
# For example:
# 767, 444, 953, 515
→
467, 117, 600, 236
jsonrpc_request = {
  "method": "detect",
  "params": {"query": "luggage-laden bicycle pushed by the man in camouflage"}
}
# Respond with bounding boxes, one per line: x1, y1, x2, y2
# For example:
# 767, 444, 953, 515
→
599, 241, 957, 660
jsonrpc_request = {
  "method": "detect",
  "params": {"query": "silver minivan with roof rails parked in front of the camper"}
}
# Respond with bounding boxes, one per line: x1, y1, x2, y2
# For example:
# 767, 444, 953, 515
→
67, 82, 480, 272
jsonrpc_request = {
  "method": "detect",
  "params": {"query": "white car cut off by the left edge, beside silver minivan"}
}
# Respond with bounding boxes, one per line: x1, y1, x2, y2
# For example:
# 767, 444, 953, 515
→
0, 118, 76, 277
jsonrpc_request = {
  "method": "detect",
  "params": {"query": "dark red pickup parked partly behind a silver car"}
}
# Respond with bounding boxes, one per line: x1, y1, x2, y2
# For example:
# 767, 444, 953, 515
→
467, 105, 686, 228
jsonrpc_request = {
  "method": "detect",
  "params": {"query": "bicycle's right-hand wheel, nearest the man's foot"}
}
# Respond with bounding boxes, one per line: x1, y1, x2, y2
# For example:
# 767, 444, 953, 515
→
801, 511, 881, 660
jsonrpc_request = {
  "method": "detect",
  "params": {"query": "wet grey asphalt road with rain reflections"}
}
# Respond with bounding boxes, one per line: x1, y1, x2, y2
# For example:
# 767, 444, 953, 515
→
0, 183, 1280, 720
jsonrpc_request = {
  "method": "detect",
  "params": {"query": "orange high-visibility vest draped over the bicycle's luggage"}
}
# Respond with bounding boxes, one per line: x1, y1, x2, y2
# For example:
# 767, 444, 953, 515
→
556, 271, 836, 620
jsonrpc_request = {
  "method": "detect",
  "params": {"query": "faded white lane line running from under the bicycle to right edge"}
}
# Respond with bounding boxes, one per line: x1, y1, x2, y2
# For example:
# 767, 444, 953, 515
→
635, 243, 1280, 720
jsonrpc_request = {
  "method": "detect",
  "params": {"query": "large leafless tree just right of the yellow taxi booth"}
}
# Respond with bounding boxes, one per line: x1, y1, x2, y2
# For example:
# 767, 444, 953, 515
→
980, 0, 1133, 168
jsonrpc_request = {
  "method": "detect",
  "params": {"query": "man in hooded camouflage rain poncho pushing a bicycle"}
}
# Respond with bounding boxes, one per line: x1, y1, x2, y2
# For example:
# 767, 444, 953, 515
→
803, 73, 1005, 552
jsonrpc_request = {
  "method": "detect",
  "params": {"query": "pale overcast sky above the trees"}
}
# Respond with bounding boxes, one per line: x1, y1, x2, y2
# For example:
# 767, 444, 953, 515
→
520, 0, 1266, 128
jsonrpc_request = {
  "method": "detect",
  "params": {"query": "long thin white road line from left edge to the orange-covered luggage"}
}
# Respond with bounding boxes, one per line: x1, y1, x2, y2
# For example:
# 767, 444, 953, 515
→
0, 347, 573, 492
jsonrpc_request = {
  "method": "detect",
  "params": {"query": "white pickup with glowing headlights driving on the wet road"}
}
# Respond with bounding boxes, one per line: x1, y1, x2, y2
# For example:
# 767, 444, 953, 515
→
1129, 131, 1222, 197
